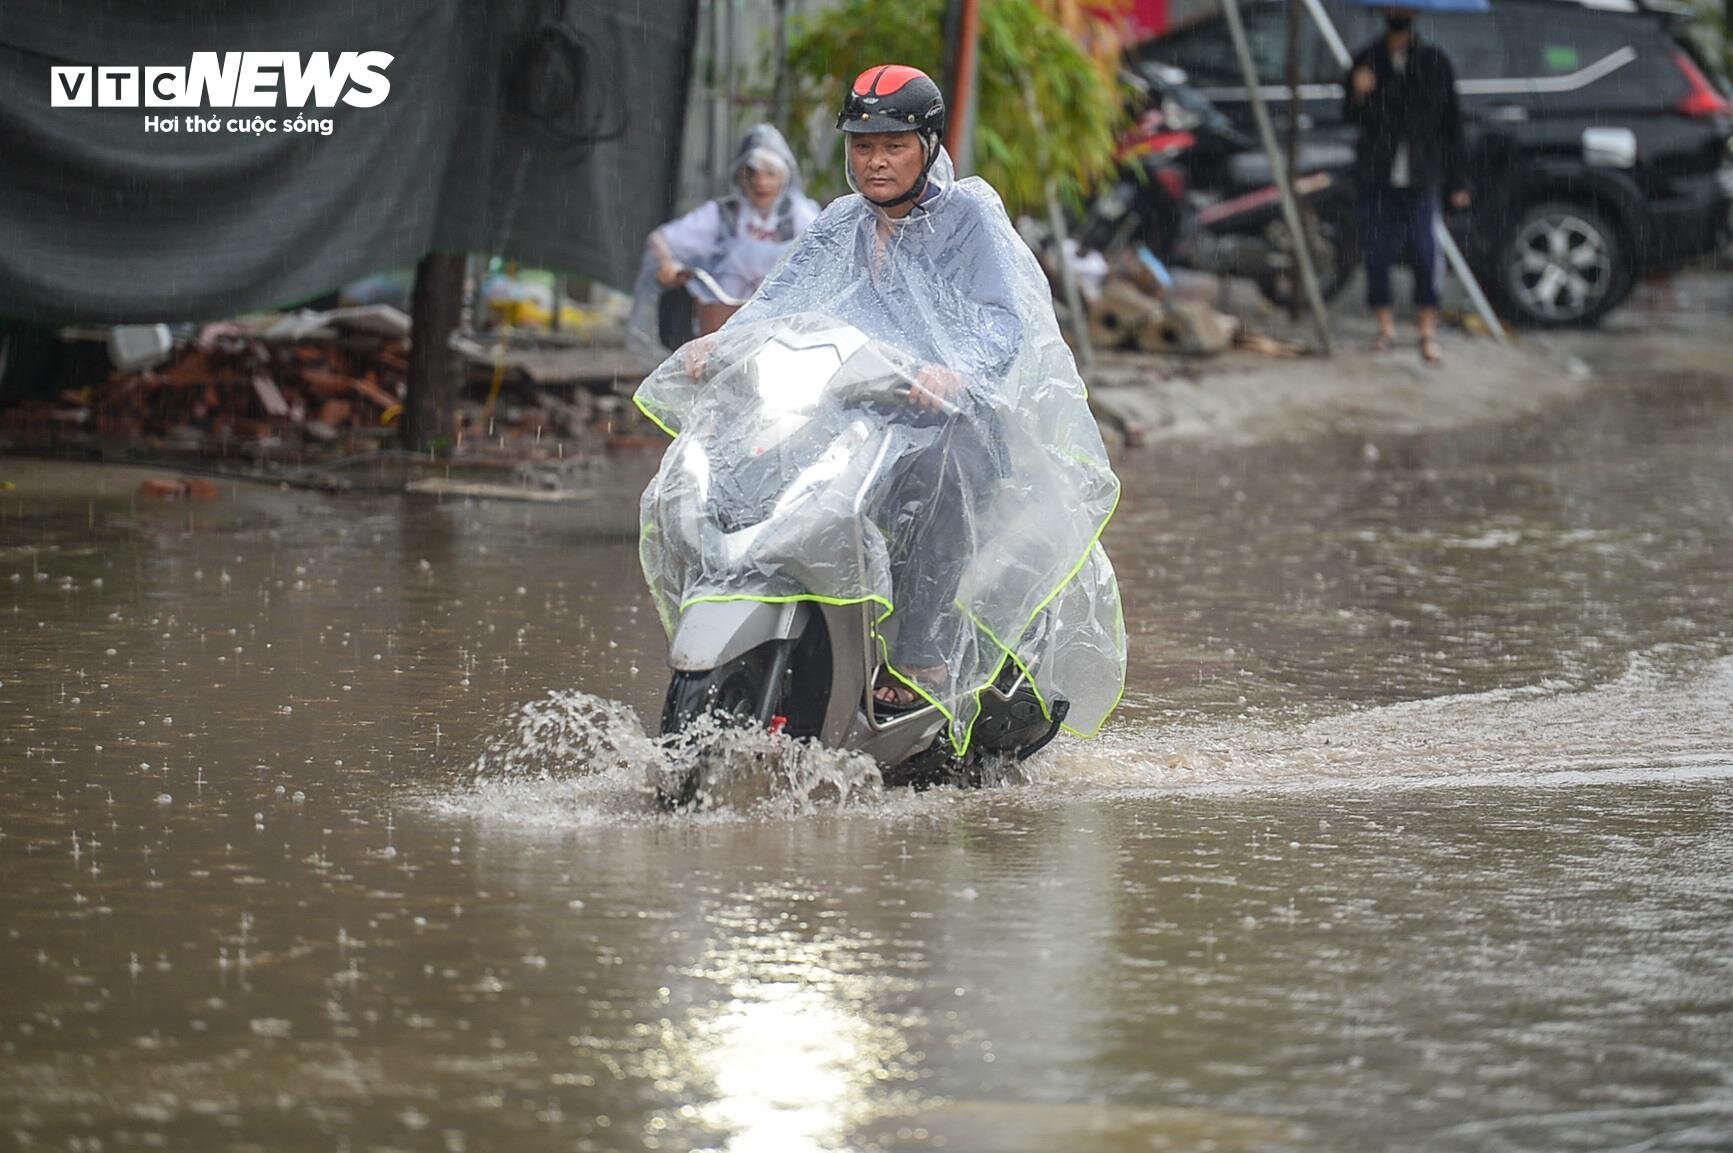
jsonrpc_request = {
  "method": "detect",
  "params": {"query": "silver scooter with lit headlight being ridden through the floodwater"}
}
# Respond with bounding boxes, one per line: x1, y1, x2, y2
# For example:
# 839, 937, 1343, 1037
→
645, 326, 1068, 808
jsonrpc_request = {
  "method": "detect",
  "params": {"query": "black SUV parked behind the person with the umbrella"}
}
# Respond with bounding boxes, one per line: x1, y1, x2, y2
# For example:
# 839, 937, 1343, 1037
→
1137, 0, 1733, 324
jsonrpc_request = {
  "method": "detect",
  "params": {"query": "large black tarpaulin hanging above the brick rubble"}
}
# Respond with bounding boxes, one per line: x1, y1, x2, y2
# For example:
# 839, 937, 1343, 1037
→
0, 0, 697, 322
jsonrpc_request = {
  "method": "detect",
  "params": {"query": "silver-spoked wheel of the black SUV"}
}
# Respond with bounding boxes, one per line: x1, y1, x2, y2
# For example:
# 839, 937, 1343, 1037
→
1496, 201, 1631, 328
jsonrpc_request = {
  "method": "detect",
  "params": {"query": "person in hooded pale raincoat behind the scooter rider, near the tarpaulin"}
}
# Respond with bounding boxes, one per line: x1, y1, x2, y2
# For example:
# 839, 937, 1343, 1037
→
631, 125, 818, 355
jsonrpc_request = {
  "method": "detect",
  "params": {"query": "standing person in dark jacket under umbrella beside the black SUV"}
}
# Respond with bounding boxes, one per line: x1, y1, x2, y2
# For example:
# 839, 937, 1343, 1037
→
1345, 9, 1468, 364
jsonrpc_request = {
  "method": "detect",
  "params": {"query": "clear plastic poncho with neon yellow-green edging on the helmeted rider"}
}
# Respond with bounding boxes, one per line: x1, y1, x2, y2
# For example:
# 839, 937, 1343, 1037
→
636, 153, 1125, 752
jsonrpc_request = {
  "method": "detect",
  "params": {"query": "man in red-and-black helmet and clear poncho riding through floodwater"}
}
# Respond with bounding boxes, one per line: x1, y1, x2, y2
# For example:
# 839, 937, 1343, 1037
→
636, 66, 1125, 752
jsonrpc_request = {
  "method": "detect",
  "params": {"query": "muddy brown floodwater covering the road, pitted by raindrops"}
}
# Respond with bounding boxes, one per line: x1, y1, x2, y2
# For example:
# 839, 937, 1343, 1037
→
0, 365, 1733, 1153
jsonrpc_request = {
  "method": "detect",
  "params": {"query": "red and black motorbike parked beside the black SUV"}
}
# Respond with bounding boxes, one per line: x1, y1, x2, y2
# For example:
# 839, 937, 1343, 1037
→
1081, 64, 1359, 307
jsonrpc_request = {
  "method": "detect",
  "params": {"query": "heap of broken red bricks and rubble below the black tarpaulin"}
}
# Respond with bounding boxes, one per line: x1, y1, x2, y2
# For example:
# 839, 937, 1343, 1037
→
0, 305, 665, 464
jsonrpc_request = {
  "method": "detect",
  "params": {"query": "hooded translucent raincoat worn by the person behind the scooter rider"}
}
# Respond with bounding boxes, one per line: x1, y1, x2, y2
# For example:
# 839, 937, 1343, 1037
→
629, 125, 818, 359
